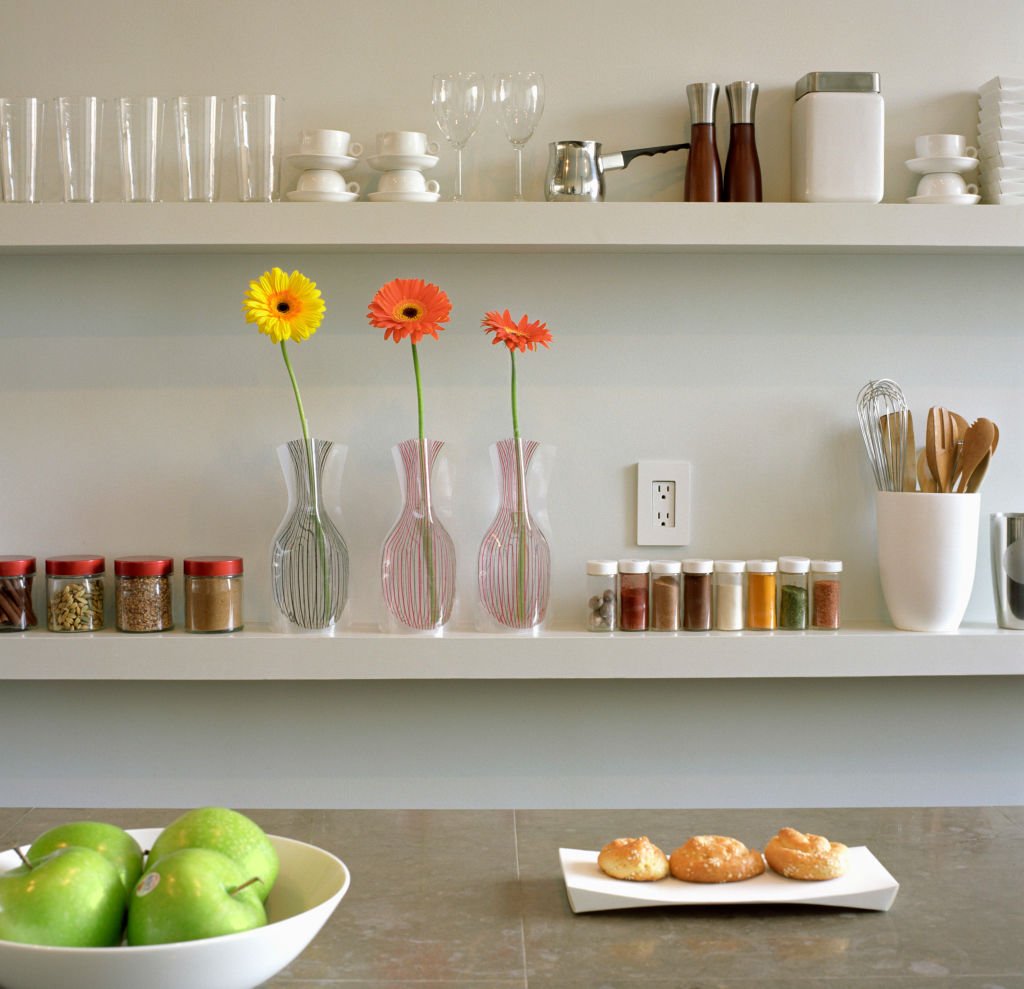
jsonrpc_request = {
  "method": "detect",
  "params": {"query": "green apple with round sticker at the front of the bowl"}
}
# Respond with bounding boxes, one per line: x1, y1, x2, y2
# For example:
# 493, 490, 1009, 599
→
127, 848, 266, 945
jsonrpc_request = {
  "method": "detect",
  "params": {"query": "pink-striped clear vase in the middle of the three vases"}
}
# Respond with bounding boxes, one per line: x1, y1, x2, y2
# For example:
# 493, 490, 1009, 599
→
381, 439, 455, 632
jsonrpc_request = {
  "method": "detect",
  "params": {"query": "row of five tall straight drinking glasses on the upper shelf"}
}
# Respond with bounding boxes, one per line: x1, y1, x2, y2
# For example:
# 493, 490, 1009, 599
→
0, 95, 282, 203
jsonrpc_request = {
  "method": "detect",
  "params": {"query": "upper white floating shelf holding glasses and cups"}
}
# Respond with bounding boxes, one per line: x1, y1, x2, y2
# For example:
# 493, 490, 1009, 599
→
0, 203, 1024, 255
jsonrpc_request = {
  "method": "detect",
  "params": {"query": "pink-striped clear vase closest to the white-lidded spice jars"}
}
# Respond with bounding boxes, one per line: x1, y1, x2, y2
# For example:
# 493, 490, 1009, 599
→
477, 439, 551, 629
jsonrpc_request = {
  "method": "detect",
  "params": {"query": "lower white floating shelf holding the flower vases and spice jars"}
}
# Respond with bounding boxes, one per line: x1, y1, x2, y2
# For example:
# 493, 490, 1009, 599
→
0, 626, 1024, 682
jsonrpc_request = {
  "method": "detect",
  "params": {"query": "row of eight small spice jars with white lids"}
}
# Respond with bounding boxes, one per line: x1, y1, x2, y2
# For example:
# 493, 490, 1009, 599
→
587, 556, 843, 632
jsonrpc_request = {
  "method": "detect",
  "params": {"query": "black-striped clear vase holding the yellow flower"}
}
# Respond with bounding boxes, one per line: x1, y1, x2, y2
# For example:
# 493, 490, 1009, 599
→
270, 439, 348, 632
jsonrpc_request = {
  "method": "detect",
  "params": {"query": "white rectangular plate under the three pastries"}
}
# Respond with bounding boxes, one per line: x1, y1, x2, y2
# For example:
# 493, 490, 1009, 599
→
558, 846, 899, 913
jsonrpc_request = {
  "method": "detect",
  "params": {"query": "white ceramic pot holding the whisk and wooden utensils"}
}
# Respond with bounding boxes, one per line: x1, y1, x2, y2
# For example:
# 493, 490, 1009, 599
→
876, 491, 981, 632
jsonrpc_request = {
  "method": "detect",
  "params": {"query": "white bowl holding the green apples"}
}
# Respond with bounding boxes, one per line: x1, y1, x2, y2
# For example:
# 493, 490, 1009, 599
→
0, 827, 350, 989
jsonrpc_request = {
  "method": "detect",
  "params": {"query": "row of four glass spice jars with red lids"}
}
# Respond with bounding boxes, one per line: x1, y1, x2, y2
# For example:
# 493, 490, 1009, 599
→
0, 556, 243, 632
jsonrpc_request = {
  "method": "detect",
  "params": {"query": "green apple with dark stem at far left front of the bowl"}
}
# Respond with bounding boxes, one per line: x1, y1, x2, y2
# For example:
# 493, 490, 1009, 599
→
0, 848, 125, 948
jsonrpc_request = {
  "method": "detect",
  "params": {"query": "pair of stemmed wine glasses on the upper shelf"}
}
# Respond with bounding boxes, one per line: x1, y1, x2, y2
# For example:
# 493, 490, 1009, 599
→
432, 72, 544, 202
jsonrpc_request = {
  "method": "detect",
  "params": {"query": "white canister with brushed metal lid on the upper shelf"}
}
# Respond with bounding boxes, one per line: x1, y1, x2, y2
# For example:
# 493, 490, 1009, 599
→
792, 72, 885, 203
